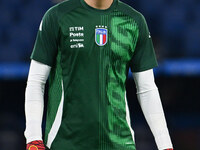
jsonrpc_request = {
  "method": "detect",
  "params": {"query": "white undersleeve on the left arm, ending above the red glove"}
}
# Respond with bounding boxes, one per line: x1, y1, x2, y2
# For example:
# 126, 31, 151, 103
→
25, 61, 50, 143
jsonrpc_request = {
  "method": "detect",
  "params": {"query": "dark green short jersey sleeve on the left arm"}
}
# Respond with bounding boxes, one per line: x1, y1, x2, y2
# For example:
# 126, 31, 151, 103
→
31, 8, 59, 66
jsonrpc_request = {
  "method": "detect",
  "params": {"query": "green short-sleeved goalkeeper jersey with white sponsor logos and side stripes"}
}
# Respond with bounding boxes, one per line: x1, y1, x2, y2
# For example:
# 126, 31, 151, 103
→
31, 0, 157, 150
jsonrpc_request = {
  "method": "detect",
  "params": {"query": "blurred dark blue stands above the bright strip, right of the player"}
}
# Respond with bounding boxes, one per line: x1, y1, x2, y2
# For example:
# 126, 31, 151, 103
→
137, 0, 200, 57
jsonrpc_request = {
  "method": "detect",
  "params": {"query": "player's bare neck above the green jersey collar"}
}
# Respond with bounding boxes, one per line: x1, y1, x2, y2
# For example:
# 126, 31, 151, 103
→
84, 0, 113, 10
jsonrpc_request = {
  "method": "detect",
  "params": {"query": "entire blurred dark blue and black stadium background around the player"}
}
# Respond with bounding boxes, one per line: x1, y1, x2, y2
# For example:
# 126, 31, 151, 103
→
0, 0, 200, 150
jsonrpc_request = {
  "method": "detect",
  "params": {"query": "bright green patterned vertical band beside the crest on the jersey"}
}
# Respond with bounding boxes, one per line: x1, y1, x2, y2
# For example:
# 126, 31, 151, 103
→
101, 10, 138, 149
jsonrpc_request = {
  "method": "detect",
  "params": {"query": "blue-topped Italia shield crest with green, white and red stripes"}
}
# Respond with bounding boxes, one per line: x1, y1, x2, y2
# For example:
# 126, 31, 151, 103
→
95, 26, 108, 46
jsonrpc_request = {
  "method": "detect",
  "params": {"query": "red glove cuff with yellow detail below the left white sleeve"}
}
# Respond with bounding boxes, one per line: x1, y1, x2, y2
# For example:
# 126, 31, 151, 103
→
26, 141, 45, 150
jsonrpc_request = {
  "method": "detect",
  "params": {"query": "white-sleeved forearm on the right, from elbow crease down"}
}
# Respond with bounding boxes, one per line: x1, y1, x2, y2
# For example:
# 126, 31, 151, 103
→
137, 89, 172, 150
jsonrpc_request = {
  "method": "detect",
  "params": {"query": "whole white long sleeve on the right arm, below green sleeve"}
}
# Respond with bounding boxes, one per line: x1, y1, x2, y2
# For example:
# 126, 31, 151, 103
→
133, 69, 173, 150
